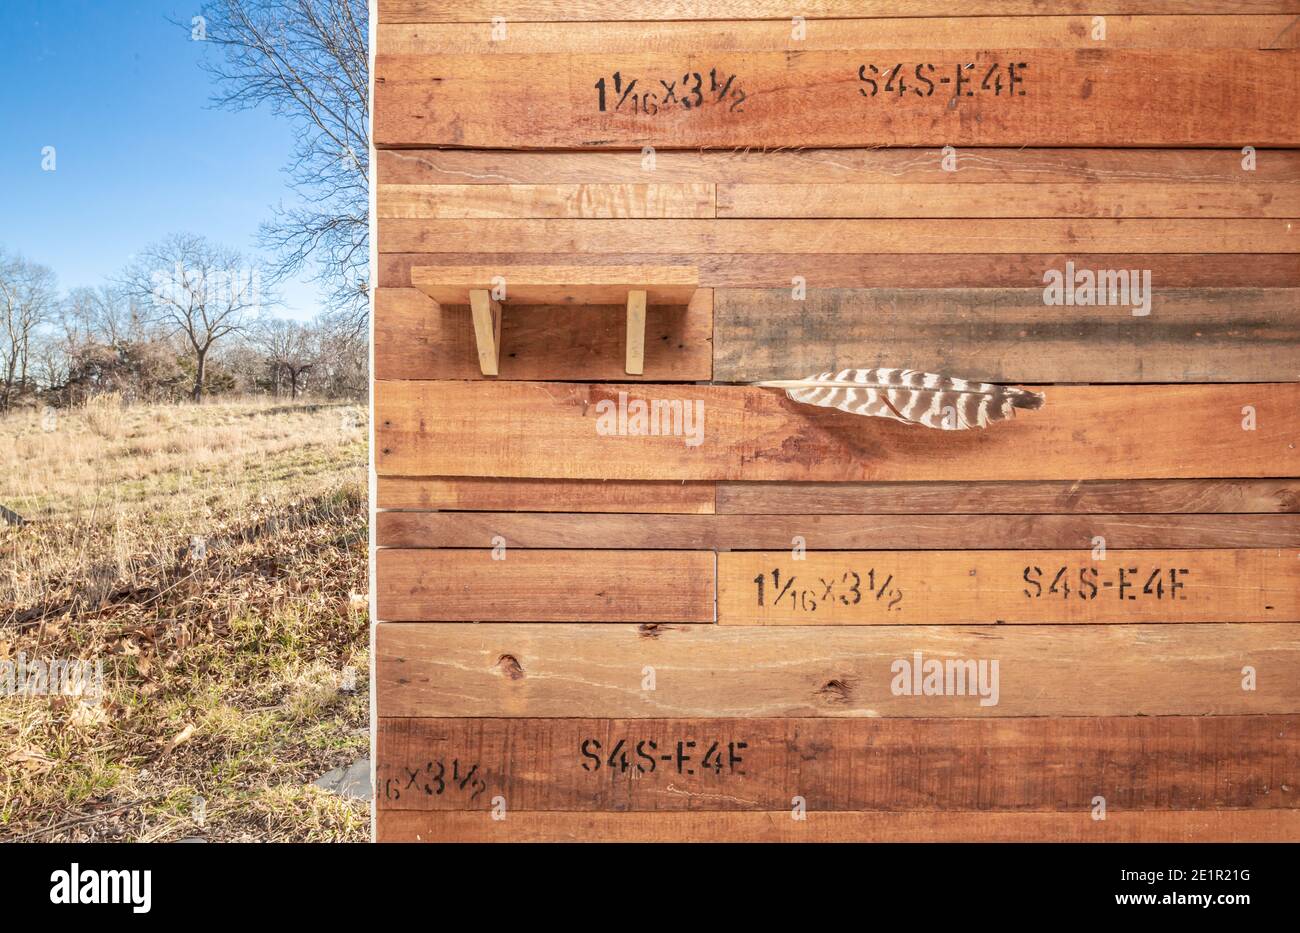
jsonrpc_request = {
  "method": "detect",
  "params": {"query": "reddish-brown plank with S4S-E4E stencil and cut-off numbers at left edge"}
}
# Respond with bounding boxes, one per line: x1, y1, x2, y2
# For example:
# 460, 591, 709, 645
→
376, 716, 1300, 812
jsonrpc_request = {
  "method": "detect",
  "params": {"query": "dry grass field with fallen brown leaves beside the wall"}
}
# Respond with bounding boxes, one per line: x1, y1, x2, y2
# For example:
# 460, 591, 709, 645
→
0, 398, 369, 841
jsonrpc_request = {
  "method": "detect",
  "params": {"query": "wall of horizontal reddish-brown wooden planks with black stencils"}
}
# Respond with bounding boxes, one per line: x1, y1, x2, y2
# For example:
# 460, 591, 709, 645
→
373, 0, 1300, 841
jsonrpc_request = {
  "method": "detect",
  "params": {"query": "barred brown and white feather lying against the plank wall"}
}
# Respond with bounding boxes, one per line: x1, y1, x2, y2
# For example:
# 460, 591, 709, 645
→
754, 368, 1044, 431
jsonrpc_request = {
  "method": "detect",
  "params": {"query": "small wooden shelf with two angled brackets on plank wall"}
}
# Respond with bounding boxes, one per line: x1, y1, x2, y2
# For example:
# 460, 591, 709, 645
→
411, 265, 699, 376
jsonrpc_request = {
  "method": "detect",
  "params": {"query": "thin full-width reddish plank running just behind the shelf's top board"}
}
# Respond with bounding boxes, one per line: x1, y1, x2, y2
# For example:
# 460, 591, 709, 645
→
378, 253, 1300, 290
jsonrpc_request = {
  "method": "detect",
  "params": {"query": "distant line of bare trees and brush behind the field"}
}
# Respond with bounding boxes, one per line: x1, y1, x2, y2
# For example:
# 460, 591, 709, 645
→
0, 235, 368, 412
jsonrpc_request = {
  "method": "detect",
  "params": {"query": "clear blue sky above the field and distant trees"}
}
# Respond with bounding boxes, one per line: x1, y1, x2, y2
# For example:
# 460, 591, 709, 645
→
0, 0, 320, 318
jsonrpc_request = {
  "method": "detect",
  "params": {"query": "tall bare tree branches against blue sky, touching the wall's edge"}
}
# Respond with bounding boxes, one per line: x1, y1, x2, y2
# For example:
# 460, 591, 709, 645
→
191, 0, 369, 333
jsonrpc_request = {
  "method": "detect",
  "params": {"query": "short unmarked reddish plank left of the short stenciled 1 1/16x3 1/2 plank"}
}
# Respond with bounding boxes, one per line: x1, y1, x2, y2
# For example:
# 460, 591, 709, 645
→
374, 548, 714, 622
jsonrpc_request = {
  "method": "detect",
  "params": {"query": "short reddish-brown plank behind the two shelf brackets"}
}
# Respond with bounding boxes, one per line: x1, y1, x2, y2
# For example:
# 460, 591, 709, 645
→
374, 287, 714, 382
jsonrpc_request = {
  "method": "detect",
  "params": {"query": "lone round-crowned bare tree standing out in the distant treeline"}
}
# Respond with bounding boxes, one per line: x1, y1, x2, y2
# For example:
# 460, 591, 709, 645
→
118, 234, 261, 402
